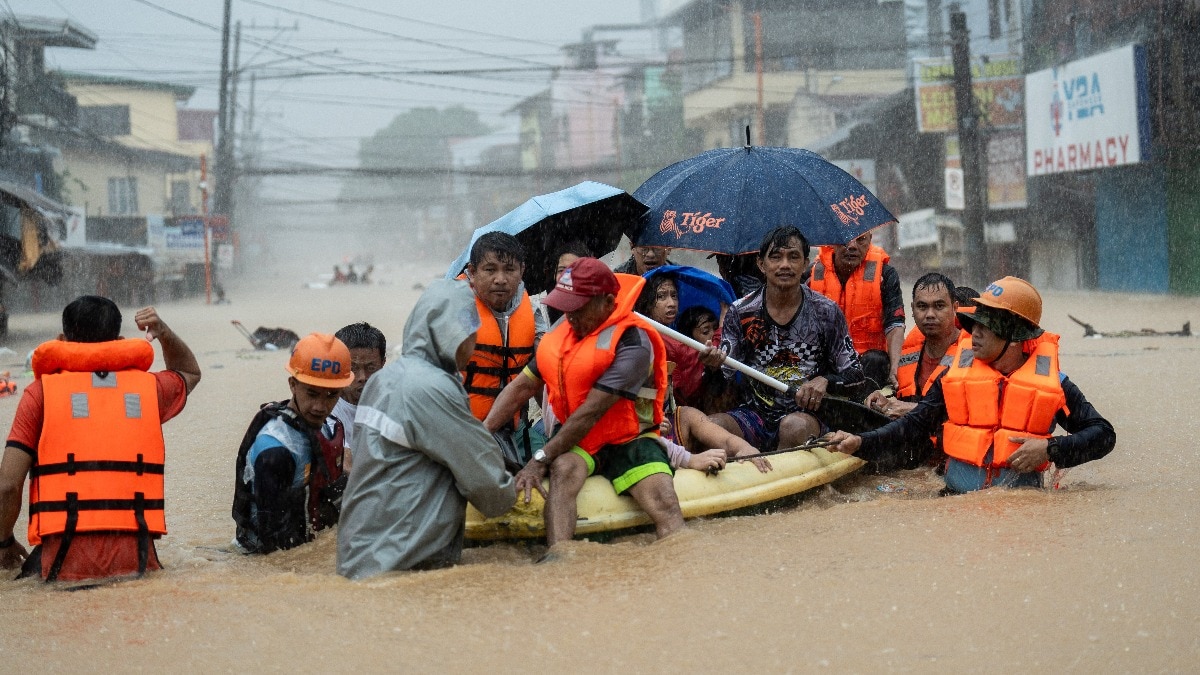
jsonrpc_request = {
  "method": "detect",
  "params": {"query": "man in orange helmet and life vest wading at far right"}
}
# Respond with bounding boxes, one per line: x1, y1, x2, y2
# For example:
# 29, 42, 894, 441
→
830, 276, 1116, 492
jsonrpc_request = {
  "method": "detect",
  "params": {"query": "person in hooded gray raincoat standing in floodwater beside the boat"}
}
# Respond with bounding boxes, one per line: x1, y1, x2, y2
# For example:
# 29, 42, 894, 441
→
337, 281, 516, 579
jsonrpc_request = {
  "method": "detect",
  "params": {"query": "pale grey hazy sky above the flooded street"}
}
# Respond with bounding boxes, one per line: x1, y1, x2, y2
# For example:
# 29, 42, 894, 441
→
7, 0, 641, 170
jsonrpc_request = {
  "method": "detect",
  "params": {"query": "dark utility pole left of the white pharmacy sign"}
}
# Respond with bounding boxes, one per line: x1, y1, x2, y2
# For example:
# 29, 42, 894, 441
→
950, 11, 988, 288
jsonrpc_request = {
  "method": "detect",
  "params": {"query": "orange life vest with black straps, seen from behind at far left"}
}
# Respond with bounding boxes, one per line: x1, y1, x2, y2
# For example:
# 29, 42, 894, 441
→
29, 340, 167, 550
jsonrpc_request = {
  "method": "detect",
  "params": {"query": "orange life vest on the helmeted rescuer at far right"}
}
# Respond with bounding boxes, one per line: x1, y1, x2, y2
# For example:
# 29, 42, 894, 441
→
942, 333, 1067, 467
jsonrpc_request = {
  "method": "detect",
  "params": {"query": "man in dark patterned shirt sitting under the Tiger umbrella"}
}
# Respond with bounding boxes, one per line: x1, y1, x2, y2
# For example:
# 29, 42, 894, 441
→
702, 226, 863, 450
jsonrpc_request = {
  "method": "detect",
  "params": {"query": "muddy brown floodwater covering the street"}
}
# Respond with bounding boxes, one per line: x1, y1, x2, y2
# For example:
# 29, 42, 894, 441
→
0, 258, 1200, 673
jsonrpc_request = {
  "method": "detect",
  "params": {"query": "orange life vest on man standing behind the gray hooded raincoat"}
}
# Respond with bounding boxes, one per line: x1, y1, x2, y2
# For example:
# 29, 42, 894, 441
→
462, 291, 536, 420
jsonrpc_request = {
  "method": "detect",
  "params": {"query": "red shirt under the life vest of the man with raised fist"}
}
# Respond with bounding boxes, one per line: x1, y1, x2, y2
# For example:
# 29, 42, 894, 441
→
7, 370, 187, 581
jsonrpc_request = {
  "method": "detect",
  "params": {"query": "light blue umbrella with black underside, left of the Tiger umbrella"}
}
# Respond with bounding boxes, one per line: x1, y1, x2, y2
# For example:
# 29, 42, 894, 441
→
446, 180, 646, 294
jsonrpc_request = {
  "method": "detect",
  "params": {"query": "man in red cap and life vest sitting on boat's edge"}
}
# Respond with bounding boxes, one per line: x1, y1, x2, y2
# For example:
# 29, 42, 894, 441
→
484, 258, 683, 546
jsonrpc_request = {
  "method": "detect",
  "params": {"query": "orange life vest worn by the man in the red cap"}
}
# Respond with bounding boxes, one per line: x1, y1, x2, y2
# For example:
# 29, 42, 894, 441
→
536, 274, 667, 455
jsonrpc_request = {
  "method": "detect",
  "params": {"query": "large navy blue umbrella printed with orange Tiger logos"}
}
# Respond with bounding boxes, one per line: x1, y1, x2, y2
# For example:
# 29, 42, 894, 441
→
632, 145, 895, 255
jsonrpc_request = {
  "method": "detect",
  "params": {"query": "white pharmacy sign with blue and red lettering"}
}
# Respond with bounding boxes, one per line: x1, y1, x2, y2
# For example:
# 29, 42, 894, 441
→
1025, 44, 1150, 175
